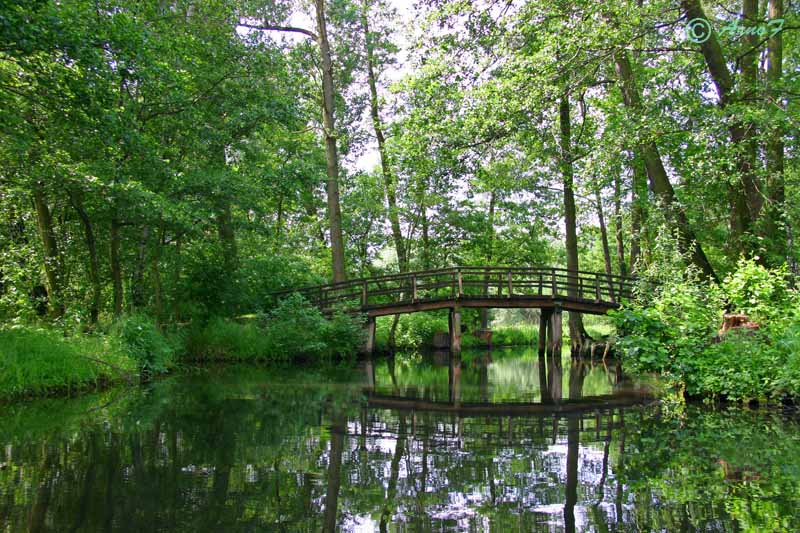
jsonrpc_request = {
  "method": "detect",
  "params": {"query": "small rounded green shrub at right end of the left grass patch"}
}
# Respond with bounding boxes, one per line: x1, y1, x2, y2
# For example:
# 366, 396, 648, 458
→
111, 314, 175, 374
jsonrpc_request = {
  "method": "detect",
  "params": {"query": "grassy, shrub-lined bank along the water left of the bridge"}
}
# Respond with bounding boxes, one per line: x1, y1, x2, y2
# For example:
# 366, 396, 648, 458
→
0, 298, 363, 400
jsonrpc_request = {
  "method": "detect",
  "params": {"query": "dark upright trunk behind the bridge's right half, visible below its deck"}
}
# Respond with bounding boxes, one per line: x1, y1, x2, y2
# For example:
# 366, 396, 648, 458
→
559, 93, 590, 355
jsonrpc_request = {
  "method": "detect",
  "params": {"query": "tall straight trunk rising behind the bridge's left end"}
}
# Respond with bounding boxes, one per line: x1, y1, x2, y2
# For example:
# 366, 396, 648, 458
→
314, 0, 347, 283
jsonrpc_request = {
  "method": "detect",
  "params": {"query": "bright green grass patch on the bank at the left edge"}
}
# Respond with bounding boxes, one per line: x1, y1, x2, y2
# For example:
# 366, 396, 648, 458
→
0, 326, 137, 399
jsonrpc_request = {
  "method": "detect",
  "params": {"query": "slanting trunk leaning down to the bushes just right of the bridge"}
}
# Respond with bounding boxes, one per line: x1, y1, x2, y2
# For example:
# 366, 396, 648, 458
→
614, 50, 717, 281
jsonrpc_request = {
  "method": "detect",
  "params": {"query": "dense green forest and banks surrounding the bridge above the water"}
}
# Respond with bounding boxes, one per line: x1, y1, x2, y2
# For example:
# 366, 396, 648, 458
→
0, 0, 800, 400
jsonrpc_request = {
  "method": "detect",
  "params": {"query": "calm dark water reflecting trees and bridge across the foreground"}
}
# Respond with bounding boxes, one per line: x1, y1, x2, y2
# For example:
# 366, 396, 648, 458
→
0, 350, 800, 532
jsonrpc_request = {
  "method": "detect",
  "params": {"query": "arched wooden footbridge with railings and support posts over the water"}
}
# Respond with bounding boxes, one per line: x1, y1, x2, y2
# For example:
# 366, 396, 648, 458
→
273, 266, 635, 352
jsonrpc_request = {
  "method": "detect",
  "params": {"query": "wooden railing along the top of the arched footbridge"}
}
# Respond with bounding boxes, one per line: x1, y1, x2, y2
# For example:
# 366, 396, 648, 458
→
273, 266, 635, 311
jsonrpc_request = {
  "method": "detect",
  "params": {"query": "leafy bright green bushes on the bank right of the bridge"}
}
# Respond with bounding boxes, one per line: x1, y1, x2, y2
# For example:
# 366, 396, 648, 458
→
614, 261, 800, 402
